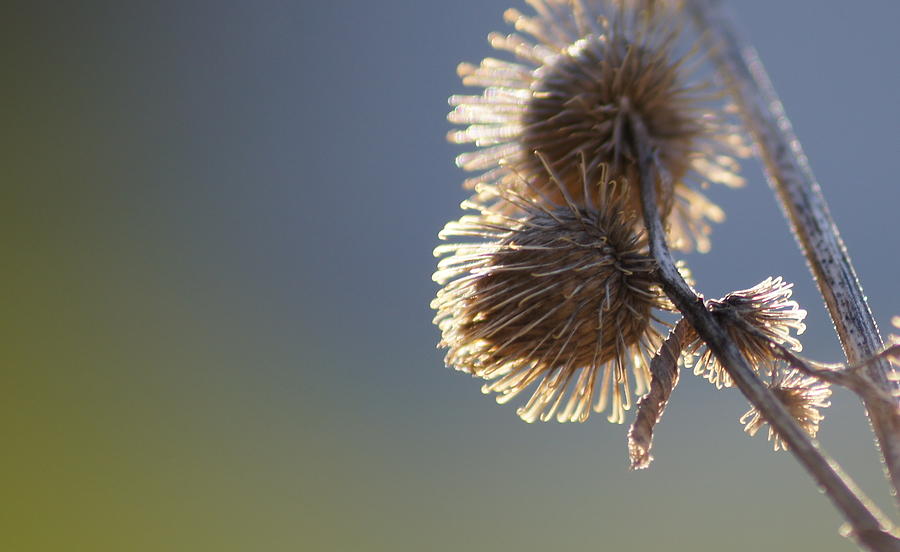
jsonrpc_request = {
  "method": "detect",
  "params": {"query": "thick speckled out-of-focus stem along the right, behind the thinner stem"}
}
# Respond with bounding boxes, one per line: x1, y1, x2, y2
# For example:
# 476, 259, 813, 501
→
684, 0, 900, 504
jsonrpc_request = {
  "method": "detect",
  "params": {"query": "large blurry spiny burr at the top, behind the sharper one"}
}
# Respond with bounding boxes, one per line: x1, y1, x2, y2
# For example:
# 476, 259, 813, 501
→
448, 0, 747, 251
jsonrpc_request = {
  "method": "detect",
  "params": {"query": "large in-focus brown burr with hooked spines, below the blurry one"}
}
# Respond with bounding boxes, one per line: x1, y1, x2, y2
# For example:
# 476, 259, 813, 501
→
432, 164, 668, 423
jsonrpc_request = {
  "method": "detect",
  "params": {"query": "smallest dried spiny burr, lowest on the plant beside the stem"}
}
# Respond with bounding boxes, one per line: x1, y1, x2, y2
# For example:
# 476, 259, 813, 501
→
740, 369, 831, 450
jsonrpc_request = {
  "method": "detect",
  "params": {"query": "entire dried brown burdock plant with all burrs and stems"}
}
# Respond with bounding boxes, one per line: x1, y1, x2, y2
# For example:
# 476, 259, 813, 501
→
432, 0, 900, 551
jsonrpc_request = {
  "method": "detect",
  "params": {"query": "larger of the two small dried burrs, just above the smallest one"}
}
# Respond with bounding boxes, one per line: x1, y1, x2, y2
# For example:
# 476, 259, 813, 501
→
685, 276, 806, 388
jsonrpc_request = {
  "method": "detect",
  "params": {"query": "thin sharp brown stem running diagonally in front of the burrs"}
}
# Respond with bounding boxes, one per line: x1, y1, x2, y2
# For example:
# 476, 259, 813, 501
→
631, 111, 900, 552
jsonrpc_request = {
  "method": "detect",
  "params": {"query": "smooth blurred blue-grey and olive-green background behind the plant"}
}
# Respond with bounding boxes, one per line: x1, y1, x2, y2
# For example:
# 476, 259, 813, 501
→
0, 0, 900, 551
